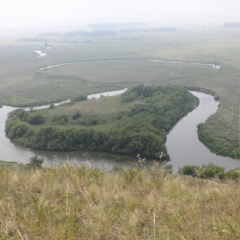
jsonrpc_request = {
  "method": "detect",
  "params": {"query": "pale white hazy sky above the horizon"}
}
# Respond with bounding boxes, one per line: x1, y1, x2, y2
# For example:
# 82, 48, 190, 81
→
0, 0, 240, 29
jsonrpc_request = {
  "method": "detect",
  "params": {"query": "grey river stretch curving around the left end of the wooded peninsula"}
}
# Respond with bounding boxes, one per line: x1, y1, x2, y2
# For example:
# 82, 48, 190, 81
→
0, 88, 130, 169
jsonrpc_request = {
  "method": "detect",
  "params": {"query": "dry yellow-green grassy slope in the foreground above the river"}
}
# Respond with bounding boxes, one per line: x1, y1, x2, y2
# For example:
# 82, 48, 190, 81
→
0, 165, 240, 240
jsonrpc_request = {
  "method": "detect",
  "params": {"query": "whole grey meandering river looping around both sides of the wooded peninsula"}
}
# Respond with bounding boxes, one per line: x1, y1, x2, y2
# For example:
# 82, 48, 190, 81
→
0, 89, 240, 171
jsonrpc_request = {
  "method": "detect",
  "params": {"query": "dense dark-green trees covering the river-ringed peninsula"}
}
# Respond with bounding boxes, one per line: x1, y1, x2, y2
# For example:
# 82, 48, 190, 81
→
5, 85, 198, 158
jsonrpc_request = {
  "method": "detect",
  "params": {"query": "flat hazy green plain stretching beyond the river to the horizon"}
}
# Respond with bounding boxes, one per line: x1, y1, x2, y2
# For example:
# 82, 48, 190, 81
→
0, 27, 240, 158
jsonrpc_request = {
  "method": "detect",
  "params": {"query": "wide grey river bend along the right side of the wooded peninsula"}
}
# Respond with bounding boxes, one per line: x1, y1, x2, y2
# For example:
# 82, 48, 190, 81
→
166, 92, 240, 171
